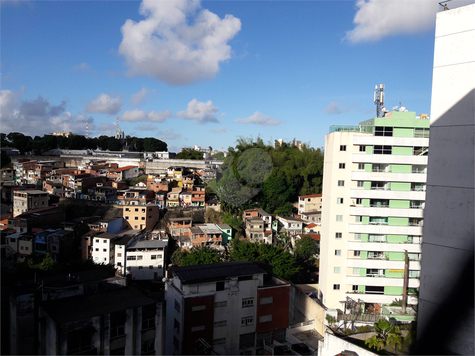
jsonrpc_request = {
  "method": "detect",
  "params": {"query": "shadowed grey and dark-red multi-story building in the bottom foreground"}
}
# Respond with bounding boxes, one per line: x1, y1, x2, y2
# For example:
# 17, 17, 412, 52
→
165, 261, 290, 355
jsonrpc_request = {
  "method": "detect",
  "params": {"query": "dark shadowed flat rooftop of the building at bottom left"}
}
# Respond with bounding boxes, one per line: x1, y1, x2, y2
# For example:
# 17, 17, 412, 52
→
42, 287, 157, 324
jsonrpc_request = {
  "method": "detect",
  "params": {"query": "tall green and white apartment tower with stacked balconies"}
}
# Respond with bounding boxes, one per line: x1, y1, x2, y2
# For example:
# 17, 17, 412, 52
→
319, 111, 430, 311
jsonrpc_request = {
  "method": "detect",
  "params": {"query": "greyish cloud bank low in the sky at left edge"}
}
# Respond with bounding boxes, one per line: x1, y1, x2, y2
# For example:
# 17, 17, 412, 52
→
0, 88, 95, 137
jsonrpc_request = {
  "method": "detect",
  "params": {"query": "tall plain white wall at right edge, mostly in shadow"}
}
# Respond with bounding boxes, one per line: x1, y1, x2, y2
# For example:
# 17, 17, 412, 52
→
417, 3, 475, 355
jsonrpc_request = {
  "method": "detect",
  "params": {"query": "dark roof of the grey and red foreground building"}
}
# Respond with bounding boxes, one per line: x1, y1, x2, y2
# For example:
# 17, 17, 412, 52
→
170, 261, 266, 284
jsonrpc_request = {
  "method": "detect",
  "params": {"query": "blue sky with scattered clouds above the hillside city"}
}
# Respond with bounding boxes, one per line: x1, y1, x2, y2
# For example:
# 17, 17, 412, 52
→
0, 0, 474, 152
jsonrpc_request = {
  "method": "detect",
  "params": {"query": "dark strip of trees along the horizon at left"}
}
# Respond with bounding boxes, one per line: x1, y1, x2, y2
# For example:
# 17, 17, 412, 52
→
0, 132, 167, 154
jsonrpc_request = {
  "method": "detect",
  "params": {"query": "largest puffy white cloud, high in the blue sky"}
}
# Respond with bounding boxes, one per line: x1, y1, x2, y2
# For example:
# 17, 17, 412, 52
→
119, 0, 241, 85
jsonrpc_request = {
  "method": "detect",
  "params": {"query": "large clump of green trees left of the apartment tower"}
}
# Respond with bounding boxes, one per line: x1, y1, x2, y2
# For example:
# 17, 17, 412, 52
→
211, 137, 323, 216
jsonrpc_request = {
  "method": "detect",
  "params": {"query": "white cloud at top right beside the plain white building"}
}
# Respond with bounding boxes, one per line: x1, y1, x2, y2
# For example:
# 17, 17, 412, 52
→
345, 0, 442, 43
